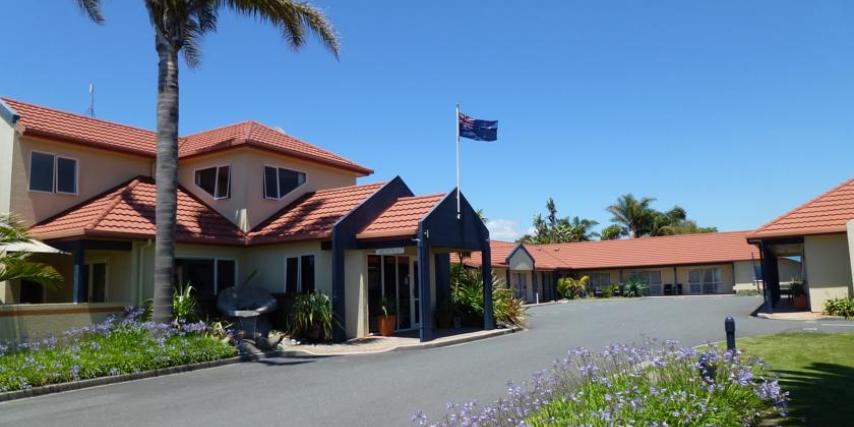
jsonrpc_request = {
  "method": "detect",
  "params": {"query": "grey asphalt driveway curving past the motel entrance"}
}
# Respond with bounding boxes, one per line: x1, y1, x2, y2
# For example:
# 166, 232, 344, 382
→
0, 296, 854, 427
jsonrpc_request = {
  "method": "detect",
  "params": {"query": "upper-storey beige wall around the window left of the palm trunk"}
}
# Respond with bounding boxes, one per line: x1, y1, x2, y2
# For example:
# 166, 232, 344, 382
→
10, 137, 154, 224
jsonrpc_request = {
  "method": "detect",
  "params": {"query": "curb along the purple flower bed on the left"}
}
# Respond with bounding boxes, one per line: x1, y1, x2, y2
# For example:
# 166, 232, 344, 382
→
0, 356, 244, 402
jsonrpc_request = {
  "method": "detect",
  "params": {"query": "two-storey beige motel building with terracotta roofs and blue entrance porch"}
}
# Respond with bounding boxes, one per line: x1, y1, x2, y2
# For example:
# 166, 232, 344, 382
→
0, 98, 494, 341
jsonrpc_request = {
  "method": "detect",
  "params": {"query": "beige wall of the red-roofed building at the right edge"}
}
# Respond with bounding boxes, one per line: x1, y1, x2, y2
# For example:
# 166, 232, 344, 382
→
804, 233, 852, 311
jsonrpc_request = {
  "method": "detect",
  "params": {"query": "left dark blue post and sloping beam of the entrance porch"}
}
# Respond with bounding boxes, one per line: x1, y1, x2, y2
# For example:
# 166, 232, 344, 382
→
331, 176, 412, 342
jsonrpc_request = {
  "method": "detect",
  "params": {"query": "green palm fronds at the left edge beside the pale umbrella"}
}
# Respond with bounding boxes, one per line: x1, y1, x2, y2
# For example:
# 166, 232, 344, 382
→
0, 213, 62, 287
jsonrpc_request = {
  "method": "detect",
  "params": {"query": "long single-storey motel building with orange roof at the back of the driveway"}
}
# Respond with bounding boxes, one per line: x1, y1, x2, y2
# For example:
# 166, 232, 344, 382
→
452, 231, 801, 303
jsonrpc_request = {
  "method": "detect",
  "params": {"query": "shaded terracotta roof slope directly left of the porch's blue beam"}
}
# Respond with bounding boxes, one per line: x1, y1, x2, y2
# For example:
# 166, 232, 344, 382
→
249, 183, 383, 243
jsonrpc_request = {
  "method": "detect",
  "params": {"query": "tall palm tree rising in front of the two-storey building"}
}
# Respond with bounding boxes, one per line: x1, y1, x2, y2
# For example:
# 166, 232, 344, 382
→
76, 0, 338, 322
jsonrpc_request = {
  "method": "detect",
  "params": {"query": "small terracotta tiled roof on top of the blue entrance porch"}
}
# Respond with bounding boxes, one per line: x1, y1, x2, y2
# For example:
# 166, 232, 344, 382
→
356, 194, 446, 239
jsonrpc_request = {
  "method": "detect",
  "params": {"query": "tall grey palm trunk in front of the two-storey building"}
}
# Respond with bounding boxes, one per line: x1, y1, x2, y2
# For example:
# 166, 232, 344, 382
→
153, 32, 178, 322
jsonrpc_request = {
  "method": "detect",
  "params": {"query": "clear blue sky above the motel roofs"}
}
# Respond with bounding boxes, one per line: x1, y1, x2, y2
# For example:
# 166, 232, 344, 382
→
0, 0, 854, 239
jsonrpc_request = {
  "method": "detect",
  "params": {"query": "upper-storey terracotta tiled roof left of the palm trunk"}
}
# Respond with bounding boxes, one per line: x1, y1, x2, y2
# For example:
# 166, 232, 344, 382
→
2, 98, 156, 157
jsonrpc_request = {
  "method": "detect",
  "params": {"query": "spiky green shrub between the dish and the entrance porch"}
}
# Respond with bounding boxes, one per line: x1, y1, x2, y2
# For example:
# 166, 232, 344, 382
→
288, 292, 333, 341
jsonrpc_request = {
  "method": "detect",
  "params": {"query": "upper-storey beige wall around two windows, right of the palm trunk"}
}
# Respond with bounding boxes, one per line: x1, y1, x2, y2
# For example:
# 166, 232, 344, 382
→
178, 147, 357, 234
